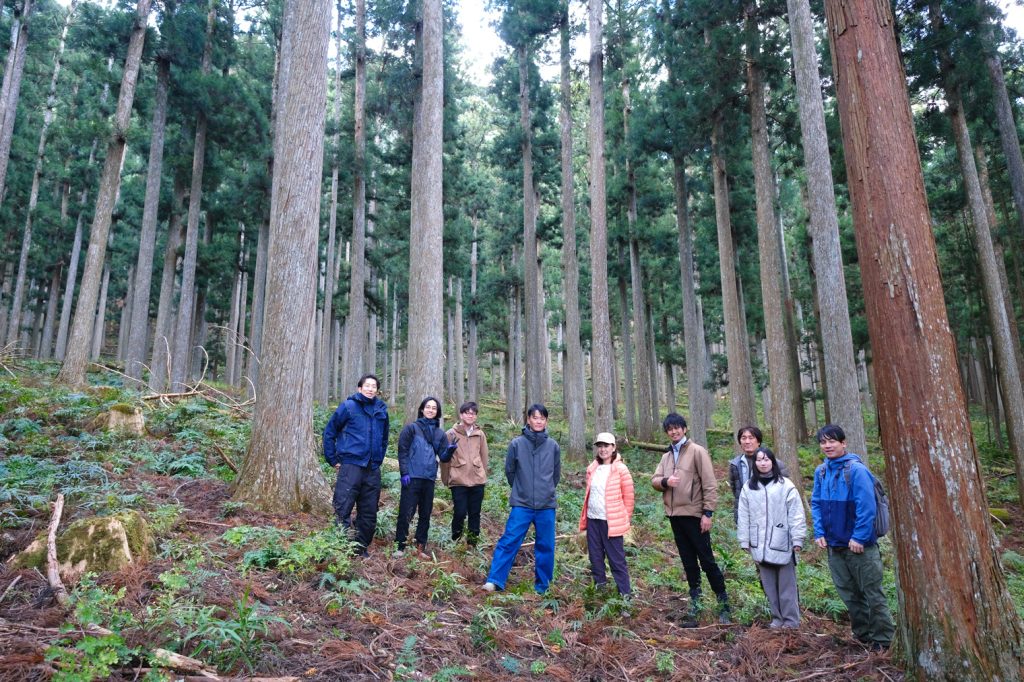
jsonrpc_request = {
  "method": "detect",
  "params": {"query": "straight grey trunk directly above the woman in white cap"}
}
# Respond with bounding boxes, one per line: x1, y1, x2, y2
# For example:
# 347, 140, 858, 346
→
588, 0, 614, 431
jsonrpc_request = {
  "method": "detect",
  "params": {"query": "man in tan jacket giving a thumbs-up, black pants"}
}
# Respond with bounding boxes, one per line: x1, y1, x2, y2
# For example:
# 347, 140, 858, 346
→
650, 413, 729, 627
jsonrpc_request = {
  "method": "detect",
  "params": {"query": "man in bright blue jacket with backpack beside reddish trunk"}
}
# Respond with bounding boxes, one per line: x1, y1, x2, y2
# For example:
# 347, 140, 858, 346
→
811, 424, 896, 650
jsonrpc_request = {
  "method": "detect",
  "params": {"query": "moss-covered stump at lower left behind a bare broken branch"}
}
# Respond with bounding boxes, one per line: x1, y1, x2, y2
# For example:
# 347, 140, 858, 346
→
11, 511, 154, 580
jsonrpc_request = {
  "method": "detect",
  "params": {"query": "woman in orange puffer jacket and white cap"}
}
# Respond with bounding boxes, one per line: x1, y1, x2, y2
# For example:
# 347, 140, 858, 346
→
580, 433, 634, 596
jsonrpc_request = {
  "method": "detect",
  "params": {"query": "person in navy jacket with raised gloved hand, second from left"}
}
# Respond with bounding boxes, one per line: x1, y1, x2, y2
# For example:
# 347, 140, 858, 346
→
394, 396, 455, 559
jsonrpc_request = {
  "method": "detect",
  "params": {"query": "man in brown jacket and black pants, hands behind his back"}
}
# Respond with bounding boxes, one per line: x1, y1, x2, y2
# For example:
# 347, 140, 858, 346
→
441, 401, 487, 547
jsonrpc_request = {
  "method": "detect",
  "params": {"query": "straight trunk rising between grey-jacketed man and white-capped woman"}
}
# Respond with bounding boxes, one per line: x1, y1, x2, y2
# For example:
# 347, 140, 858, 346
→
561, 5, 587, 459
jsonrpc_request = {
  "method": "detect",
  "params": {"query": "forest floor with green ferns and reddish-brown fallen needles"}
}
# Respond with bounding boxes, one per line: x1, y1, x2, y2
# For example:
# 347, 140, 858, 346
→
0, 364, 1024, 681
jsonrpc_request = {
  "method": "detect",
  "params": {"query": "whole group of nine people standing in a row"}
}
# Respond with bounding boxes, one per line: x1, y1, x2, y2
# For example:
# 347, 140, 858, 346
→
324, 375, 895, 649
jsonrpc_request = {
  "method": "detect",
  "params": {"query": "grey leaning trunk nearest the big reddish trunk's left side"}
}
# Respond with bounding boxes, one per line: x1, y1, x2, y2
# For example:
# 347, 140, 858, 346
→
787, 0, 867, 453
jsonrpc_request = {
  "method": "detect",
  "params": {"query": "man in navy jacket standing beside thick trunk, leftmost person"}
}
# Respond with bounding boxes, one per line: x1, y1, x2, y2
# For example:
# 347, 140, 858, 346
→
324, 374, 390, 556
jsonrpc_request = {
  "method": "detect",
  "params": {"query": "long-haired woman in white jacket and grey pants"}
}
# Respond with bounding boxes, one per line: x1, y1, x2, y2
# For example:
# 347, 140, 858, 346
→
736, 447, 807, 628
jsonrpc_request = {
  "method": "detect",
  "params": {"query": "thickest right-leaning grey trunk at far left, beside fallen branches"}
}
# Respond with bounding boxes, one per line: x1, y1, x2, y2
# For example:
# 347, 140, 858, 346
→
57, 0, 152, 385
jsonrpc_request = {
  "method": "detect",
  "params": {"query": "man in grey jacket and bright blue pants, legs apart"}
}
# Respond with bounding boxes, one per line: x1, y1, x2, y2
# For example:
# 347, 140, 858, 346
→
483, 403, 562, 594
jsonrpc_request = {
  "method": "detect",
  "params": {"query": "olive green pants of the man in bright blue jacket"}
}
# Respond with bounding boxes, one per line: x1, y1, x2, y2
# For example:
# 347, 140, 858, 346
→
828, 545, 896, 647
